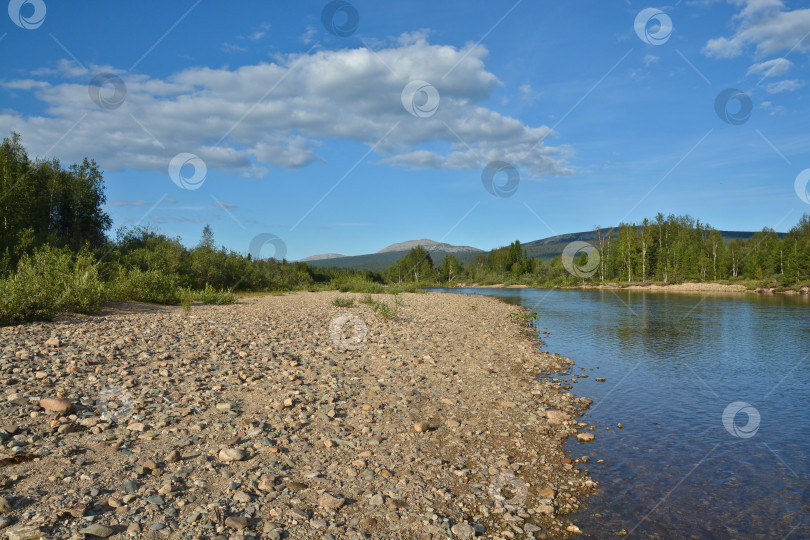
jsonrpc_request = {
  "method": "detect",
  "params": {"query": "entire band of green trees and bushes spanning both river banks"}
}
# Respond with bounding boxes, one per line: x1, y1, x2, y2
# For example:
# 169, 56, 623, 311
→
0, 133, 810, 324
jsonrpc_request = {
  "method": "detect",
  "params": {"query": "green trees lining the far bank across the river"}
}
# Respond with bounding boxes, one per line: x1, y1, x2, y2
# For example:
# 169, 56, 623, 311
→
382, 213, 810, 287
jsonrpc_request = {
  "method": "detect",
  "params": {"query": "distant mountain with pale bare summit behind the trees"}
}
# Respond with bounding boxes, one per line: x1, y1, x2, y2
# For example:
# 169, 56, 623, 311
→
301, 238, 485, 272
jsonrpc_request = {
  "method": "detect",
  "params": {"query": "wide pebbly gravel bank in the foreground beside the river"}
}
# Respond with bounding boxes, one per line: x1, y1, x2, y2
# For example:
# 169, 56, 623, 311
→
0, 292, 595, 540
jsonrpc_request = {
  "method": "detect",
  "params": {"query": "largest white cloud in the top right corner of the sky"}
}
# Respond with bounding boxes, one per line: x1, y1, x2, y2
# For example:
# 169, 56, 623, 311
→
703, 0, 810, 58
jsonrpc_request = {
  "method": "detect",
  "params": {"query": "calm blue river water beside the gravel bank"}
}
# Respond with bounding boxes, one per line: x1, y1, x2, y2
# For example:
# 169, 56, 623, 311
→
434, 289, 810, 539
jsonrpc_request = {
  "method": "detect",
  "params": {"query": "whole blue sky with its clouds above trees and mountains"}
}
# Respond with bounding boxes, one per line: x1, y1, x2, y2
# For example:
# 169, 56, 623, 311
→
0, 0, 810, 259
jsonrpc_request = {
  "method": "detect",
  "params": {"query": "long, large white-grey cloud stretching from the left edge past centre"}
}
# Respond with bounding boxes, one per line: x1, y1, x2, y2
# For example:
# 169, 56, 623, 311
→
0, 33, 572, 176
